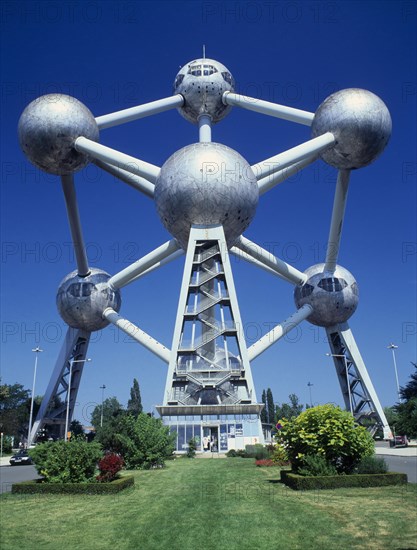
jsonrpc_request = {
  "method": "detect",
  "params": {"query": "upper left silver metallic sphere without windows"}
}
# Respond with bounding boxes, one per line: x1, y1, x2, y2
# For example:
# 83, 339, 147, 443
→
18, 94, 99, 176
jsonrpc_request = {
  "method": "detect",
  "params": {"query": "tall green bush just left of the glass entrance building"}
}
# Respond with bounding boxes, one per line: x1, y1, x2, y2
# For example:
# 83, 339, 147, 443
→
96, 413, 175, 470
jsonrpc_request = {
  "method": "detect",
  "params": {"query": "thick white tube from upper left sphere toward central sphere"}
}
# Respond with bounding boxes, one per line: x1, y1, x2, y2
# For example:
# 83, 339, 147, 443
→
74, 137, 161, 183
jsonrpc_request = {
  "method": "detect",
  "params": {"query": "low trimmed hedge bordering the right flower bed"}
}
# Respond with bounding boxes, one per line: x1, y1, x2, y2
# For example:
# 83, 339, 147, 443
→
281, 470, 407, 491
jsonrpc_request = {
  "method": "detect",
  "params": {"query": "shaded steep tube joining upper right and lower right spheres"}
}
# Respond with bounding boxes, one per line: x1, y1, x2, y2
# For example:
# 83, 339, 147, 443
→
324, 170, 350, 271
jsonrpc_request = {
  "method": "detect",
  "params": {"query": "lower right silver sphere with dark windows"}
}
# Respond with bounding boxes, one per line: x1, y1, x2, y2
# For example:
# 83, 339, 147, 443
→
294, 264, 359, 327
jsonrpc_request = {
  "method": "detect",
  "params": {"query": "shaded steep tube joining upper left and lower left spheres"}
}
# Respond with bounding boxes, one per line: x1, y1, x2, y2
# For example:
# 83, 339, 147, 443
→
61, 174, 90, 277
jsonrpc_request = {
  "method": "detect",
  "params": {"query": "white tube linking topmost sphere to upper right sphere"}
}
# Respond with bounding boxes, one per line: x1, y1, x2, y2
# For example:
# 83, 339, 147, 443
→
223, 92, 314, 126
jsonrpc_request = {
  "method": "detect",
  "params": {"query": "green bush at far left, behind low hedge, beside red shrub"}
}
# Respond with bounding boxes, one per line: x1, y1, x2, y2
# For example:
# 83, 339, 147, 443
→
29, 437, 102, 483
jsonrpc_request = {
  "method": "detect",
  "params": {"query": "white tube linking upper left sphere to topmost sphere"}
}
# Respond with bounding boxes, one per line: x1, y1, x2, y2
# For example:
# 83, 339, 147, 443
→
96, 94, 184, 130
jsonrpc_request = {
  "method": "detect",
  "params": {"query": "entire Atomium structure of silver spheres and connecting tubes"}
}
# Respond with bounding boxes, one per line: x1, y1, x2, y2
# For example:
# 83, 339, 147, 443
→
19, 56, 391, 446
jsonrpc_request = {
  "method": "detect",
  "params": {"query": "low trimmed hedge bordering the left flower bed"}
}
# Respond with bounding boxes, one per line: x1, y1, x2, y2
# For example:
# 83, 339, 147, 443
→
12, 475, 134, 495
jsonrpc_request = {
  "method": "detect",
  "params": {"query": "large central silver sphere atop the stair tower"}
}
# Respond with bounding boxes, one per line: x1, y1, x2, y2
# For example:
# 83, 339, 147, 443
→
154, 143, 259, 249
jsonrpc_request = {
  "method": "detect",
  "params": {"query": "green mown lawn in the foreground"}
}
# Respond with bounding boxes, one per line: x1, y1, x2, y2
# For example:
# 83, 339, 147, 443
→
0, 458, 417, 550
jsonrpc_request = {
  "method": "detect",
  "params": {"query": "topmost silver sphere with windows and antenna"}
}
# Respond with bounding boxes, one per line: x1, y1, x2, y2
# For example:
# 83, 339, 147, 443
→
174, 59, 235, 124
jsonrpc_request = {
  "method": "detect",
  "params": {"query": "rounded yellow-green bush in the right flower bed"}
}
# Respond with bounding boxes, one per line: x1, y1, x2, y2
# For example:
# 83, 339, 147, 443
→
275, 404, 374, 473
